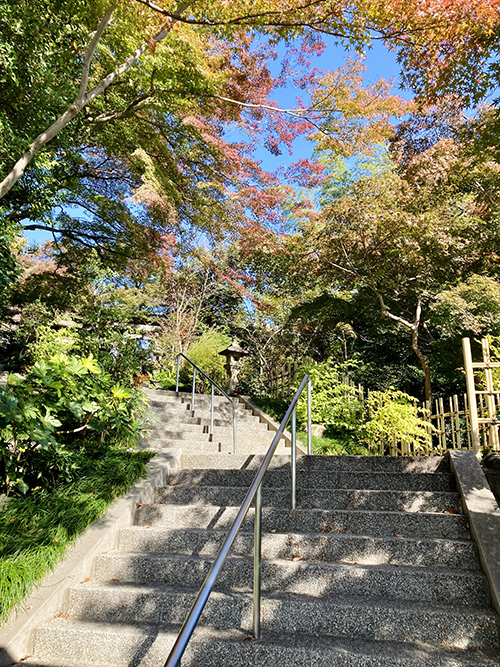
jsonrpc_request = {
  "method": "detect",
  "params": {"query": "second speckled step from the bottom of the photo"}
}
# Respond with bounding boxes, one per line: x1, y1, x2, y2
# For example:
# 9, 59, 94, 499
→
35, 586, 498, 652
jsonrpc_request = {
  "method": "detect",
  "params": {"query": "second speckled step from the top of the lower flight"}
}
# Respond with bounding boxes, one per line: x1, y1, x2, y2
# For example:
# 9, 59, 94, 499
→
169, 468, 456, 493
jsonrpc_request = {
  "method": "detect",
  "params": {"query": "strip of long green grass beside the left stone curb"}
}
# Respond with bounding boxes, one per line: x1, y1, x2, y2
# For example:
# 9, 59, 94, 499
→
0, 443, 152, 625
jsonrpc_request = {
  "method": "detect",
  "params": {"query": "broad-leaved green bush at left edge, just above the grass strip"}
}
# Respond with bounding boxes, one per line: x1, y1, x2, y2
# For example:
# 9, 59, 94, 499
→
0, 354, 143, 495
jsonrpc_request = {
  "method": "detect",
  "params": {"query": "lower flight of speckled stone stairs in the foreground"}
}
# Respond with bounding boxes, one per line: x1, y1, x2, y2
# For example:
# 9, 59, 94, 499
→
18, 395, 500, 667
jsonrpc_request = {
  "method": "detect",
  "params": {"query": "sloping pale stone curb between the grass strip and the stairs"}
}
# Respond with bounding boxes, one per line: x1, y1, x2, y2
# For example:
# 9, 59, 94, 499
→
0, 449, 181, 667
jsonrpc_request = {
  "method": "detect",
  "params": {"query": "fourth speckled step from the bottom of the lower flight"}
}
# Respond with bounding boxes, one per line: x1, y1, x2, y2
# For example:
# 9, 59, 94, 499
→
118, 526, 480, 570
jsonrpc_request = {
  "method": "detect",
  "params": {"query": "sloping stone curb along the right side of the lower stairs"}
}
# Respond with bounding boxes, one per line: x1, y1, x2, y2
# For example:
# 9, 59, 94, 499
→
450, 450, 500, 613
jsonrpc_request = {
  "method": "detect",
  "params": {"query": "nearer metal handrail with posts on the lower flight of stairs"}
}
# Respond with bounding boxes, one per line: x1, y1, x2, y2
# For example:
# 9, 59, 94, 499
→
164, 375, 311, 667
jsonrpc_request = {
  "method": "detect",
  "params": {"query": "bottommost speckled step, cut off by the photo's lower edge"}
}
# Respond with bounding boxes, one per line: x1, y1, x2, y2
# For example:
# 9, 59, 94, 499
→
27, 619, 500, 667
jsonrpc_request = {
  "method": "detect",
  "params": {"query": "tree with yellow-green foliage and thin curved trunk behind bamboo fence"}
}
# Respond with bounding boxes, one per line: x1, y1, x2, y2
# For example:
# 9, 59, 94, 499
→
292, 132, 499, 402
